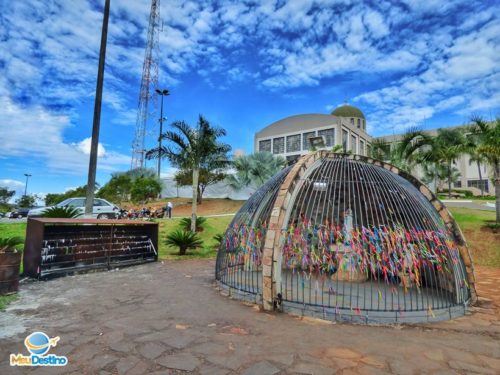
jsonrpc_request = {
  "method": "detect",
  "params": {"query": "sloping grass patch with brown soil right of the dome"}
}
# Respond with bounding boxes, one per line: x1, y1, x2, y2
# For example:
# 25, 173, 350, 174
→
448, 207, 500, 267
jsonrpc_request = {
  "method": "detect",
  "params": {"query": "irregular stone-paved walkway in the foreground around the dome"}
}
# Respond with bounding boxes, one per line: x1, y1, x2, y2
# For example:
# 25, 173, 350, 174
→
0, 260, 500, 375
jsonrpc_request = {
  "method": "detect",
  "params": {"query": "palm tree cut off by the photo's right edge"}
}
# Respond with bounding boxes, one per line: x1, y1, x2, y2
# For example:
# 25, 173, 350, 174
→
470, 118, 500, 224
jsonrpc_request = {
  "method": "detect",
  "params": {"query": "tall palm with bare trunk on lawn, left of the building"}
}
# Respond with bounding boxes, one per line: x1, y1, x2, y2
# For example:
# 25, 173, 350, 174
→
146, 115, 231, 232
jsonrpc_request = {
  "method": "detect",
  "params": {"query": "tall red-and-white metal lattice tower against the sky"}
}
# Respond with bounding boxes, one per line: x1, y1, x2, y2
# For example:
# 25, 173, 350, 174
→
130, 0, 160, 169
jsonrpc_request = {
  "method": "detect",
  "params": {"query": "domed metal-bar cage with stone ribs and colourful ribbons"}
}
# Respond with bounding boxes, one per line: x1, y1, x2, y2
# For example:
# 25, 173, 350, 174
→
216, 151, 476, 323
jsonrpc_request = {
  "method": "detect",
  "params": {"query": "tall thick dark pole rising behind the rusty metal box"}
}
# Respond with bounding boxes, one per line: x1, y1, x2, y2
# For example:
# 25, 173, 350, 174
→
85, 0, 110, 216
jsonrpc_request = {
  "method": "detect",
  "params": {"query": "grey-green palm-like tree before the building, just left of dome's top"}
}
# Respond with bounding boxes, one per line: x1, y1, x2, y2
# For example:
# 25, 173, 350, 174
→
226, 152, 287, 190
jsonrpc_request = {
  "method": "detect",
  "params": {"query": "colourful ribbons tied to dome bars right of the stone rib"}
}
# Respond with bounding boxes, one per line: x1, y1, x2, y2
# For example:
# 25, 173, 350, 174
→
282, 221, 459, 286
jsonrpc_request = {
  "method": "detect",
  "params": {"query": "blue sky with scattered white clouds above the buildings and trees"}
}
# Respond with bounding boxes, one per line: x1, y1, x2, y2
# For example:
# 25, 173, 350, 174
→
0, 0, 500, 201
